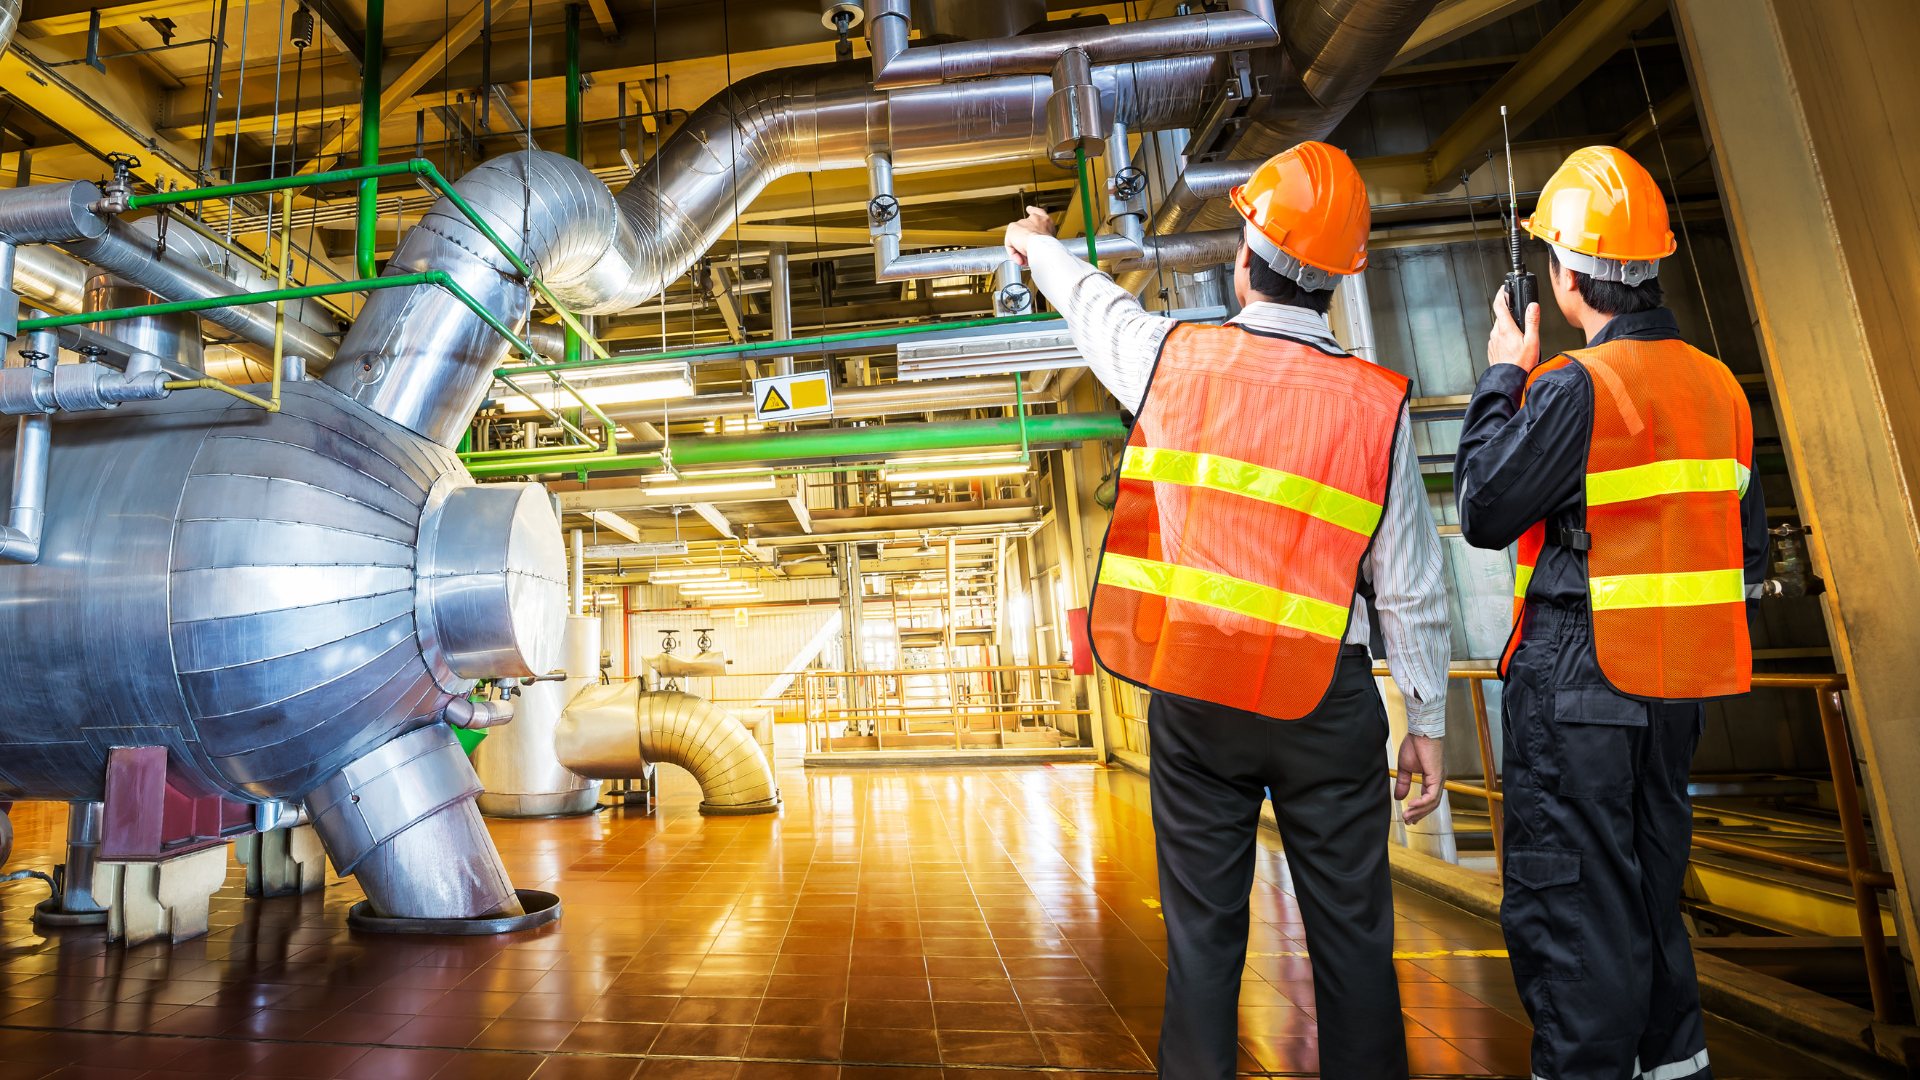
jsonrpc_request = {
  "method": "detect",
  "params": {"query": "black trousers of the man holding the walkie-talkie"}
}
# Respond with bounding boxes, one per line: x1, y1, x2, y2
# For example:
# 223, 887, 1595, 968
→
1500, 607, 1711, 1080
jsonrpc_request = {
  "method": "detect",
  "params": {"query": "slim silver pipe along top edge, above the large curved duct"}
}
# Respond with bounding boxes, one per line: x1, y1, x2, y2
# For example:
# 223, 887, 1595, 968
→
870, 0, 1281, 90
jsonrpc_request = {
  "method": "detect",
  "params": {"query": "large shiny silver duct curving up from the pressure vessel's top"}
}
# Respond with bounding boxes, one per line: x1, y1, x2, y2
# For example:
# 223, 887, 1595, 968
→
326, 56, 1217, 446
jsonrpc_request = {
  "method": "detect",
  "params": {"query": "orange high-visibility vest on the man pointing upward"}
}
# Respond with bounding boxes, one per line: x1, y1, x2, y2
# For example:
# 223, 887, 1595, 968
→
1089, 325, 1407, 719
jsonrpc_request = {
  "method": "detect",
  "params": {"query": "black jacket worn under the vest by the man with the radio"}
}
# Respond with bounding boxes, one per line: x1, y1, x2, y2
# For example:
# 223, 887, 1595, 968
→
1453, 307, 1766, 680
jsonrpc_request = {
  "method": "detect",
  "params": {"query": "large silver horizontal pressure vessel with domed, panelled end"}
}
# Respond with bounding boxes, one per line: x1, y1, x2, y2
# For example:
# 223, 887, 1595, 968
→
0, 382, 566, 803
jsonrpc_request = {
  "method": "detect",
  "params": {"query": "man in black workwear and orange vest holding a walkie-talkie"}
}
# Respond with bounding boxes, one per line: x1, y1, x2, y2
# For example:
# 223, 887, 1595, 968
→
1453, 148, 1766, 1080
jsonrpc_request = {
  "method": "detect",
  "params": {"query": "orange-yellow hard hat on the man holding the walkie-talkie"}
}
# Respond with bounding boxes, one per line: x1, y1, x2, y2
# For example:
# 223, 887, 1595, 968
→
1521, 146, 1674, 263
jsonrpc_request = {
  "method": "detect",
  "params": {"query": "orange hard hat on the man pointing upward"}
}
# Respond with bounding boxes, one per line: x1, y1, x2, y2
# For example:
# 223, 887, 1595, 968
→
1227, 142, 1373, 288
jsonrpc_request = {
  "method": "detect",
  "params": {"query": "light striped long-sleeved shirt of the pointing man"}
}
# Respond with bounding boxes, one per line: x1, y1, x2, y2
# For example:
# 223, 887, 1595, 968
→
1027, 236, 1453, 738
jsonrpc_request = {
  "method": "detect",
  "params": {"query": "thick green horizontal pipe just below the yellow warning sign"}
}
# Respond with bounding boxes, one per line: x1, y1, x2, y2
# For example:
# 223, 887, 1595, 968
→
468, 413, 1127, 479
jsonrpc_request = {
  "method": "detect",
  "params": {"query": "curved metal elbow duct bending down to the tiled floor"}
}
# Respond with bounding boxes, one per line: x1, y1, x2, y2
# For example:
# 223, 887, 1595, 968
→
553, 680, 780, 815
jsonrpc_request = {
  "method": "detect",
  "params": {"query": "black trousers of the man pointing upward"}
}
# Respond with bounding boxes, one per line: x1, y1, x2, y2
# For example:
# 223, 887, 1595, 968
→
1146, 646, 1407, 1080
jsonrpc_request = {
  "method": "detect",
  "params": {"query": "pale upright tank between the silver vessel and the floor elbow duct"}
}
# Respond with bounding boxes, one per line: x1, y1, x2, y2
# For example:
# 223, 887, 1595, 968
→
472, 615, 601, 817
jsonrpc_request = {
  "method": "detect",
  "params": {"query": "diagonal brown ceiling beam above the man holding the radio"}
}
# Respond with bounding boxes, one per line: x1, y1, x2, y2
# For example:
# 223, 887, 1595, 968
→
1427, 0, 1667, 192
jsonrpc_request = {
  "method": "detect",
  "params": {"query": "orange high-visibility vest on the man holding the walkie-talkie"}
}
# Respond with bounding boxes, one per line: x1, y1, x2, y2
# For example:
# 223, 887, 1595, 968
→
1500, 340, 1753, 700
